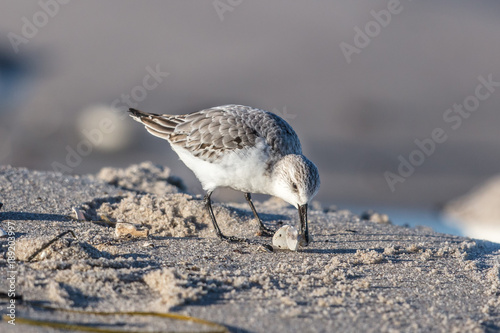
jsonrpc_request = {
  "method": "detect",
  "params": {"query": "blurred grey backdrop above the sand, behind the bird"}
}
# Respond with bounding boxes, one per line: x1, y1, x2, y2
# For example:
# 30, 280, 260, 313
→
0, 0, 500, 241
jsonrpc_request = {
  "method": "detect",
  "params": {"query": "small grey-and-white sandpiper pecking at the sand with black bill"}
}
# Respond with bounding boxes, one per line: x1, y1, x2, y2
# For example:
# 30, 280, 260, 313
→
129, 105, 320, 245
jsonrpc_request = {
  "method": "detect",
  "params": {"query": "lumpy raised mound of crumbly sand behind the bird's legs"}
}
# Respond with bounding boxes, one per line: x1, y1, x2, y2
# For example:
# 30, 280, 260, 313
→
77, 162, 254, 237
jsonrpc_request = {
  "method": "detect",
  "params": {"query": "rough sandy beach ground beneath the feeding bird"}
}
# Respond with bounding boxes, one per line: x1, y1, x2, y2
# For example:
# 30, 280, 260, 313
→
0, 162, 500, 332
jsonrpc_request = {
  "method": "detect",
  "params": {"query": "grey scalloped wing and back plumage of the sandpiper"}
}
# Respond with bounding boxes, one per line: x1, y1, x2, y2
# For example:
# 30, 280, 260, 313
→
130, 105, 301, 162
